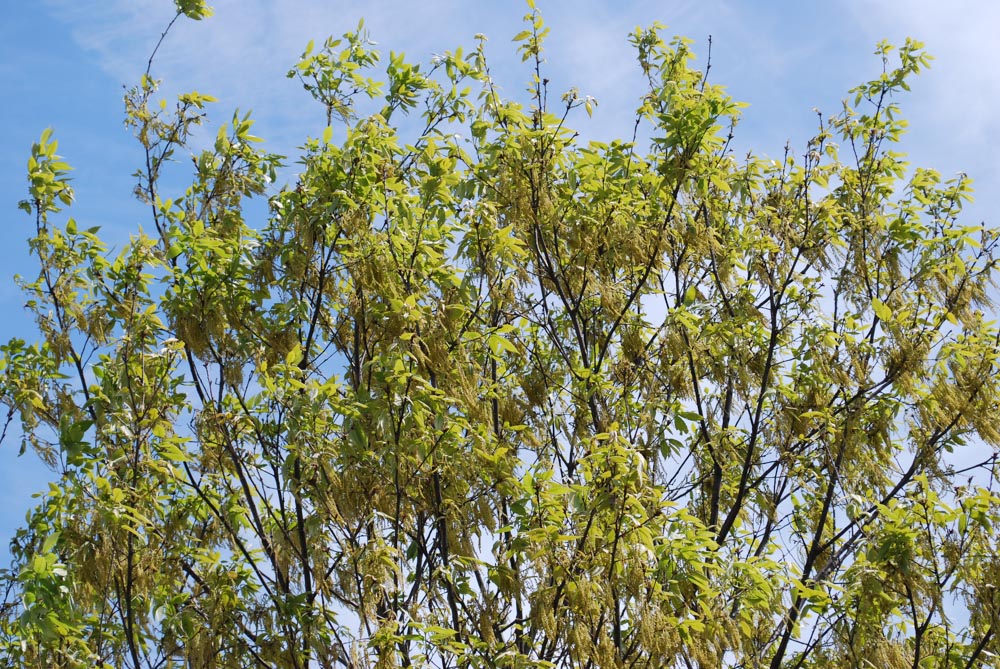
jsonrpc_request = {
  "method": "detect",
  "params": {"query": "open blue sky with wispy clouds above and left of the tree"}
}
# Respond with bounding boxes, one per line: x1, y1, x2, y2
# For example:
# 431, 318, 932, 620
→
0, 0, 1000, 566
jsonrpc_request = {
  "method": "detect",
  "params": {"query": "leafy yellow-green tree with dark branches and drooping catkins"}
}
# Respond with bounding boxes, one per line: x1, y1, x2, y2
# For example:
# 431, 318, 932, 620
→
0, 2, 1000, 669
